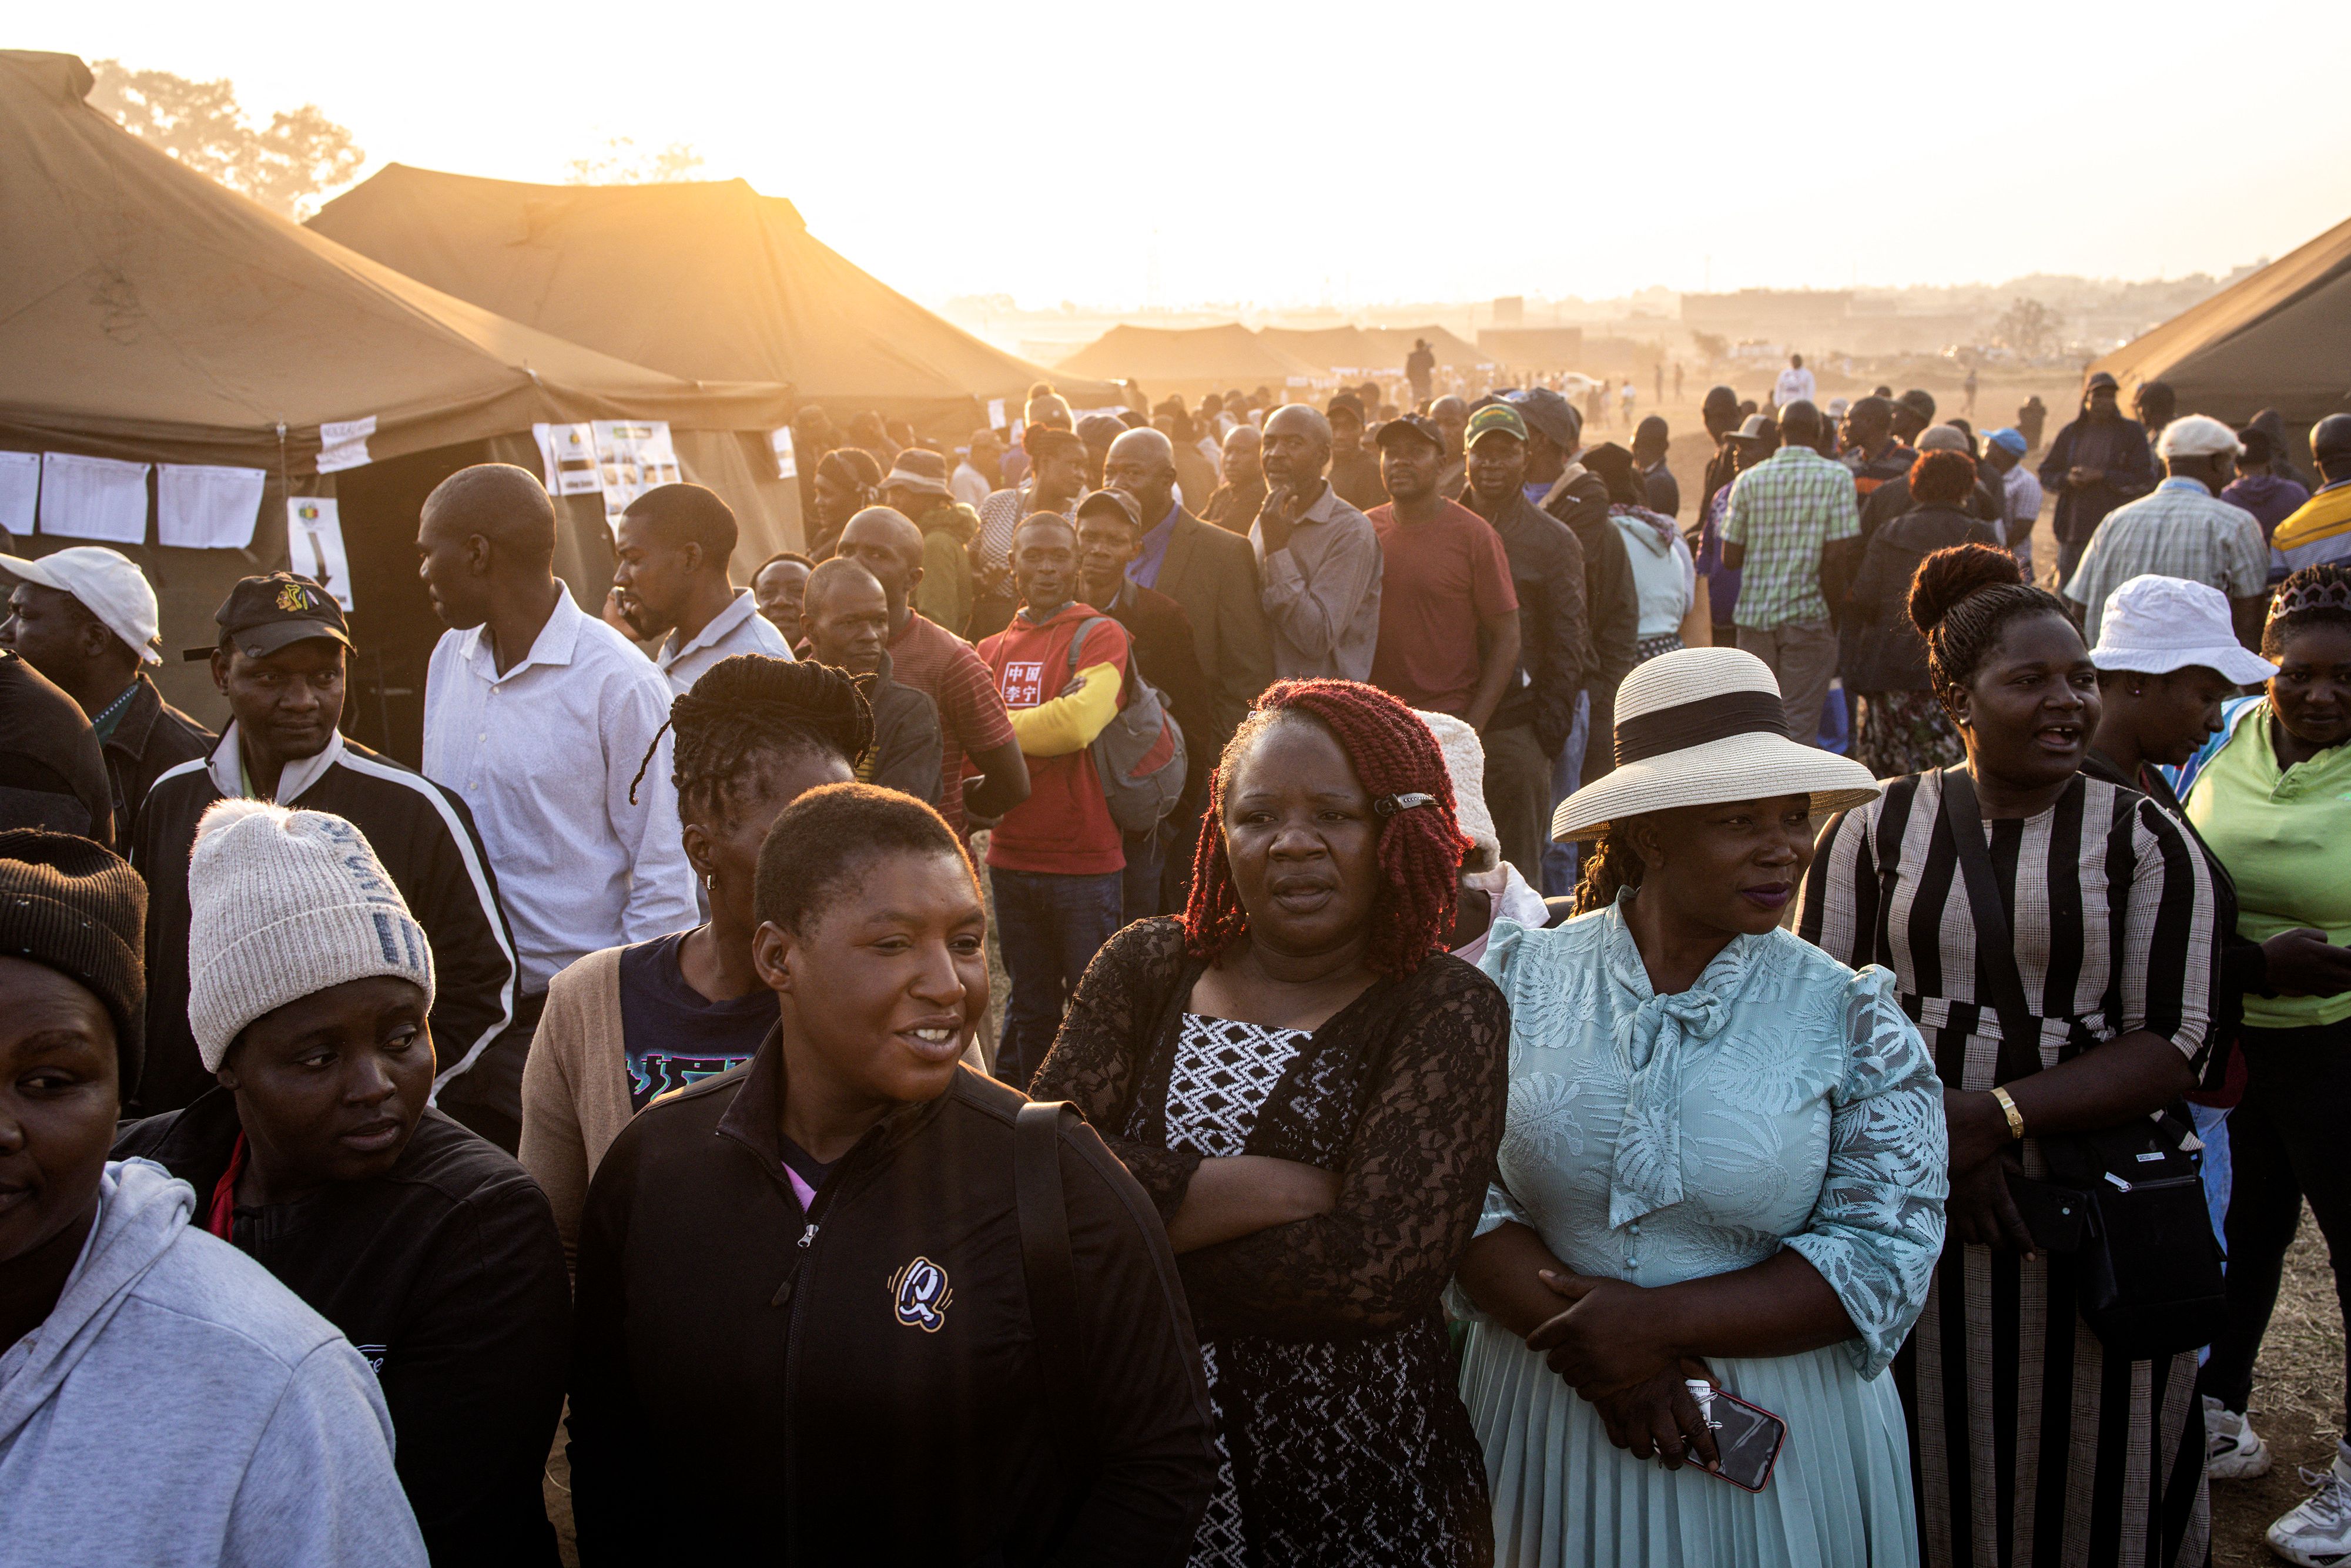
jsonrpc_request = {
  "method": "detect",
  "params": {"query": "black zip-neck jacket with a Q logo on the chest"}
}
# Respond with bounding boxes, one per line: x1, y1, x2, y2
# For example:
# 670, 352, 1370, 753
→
569, 1034, 1215, 1568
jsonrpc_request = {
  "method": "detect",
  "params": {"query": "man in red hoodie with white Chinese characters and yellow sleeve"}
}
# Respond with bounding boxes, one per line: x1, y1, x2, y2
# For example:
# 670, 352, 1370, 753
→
980, 512, 1128, 1088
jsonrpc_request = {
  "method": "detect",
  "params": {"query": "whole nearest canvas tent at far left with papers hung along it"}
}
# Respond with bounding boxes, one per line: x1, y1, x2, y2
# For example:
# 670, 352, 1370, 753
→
0, 52, 797, 755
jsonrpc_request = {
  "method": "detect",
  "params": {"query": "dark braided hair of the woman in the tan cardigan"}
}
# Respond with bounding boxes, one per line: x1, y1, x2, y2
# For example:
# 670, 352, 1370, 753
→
628, 654, 875, 820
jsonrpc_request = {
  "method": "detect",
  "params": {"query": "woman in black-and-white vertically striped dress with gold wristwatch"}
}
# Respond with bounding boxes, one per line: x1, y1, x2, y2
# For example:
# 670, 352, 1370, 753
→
1799, 545, 2215, 1568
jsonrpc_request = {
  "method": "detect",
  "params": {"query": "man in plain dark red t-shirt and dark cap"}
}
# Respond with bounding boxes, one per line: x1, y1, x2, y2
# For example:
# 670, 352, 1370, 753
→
1368, 414, 1519, 729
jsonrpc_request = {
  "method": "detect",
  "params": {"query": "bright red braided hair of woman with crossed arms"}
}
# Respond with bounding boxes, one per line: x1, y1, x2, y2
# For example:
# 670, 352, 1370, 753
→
1183, 679, 1472, 976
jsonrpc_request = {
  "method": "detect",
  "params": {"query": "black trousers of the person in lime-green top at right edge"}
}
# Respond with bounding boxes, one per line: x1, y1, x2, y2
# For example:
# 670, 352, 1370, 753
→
2196, 1020, 2351, 1420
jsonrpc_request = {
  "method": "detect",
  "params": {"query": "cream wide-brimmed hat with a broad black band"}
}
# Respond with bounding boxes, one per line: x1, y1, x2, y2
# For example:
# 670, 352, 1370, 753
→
1552, 649, 1878, 839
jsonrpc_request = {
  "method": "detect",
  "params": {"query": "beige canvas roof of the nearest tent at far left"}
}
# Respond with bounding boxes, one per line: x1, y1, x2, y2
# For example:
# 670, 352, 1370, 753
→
0, 52, 792, 477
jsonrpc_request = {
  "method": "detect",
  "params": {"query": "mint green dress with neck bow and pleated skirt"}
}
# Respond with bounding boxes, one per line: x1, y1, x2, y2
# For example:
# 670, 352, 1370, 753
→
1455, 907, 1947, 1568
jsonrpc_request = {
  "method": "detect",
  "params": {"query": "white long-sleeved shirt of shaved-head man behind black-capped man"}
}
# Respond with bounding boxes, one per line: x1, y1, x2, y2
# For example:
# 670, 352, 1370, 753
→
426, 588, 701, 992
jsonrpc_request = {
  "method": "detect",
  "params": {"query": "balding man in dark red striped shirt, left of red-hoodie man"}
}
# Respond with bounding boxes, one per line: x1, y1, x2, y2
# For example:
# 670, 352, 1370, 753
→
835, 505, 1030, 832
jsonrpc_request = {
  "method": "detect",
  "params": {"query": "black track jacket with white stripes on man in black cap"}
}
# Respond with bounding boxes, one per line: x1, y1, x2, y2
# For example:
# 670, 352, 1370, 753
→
125, 738, 515, 1117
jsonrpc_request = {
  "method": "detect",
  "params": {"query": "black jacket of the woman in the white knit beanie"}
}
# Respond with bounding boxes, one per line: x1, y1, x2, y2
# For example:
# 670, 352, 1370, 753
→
115, 1088, 571, 1568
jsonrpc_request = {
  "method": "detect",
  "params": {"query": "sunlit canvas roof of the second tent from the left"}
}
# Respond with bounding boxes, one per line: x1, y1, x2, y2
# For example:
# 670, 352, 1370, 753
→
310, 165, 1117, 435
